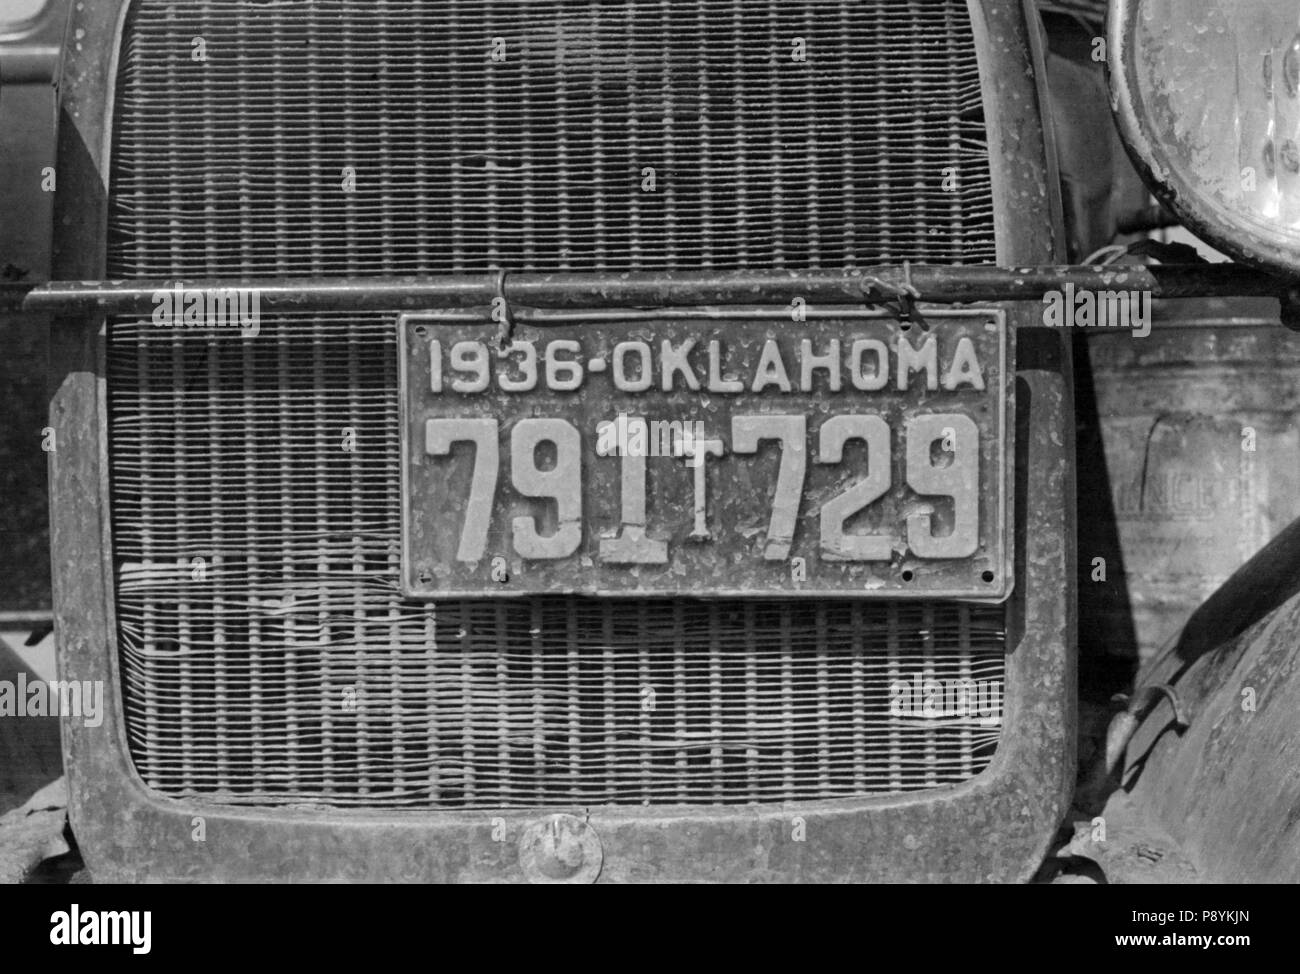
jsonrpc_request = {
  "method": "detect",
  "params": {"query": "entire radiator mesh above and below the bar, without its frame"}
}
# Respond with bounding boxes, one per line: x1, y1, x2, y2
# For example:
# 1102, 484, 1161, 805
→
108, 0, 1006, 809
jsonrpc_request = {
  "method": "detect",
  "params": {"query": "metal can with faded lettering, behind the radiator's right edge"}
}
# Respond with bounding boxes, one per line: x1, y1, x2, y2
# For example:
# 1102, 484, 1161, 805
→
1080, 318, 1300, 659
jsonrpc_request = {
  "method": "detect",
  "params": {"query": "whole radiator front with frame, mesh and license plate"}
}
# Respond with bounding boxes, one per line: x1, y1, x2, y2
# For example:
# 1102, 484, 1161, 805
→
43, 0, 1075, 882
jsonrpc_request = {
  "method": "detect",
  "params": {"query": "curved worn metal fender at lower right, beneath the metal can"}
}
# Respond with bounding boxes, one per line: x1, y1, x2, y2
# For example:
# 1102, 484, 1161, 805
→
1092, 475, 1300, 883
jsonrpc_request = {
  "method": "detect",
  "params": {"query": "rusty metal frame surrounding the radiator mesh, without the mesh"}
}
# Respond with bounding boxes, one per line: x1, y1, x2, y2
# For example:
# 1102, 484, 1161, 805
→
43, 0, 1075, 882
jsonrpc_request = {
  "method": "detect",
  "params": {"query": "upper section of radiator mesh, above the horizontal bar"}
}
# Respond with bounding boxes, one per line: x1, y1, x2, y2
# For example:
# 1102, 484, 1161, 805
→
112, 0, 995, 274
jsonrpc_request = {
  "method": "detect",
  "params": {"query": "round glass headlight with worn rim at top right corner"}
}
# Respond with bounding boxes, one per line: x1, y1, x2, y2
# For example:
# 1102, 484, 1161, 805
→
1109, 0, 1300, 273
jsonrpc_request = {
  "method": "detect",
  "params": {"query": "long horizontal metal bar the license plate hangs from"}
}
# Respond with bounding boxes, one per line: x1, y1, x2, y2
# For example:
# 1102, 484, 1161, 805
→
0, 264, 1296, 315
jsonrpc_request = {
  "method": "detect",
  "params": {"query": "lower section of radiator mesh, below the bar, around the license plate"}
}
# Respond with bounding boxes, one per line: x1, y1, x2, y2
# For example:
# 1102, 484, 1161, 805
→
108, 316, 1006, 808
